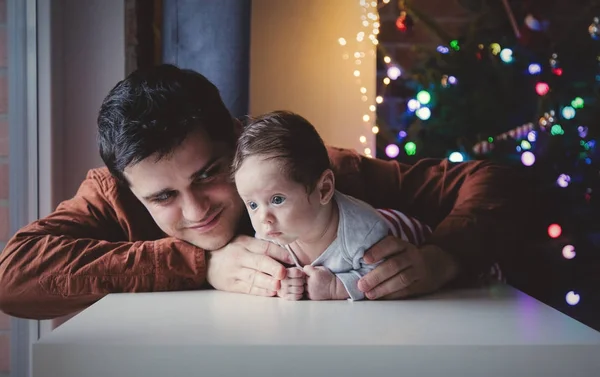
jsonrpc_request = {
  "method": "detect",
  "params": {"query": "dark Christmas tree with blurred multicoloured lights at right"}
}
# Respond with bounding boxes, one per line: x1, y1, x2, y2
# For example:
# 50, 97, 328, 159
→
377, 0, 600, 329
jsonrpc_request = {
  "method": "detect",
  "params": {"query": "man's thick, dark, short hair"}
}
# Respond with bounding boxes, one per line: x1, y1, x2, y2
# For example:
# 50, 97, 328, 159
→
98, 64, 236, 183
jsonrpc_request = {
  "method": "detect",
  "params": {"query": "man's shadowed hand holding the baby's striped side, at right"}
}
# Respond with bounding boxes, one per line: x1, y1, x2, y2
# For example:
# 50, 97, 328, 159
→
358, 236, 459, 300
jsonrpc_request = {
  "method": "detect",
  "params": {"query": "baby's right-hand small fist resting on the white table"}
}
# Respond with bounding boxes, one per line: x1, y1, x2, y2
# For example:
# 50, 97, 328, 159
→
304, 265, 349, 300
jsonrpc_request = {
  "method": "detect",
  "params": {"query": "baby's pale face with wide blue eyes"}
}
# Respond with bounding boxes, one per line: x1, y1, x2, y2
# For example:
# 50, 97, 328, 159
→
235, 156, 321, 245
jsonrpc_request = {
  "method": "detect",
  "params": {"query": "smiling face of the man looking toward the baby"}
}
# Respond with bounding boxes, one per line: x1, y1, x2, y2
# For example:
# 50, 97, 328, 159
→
124, 131, 244, 250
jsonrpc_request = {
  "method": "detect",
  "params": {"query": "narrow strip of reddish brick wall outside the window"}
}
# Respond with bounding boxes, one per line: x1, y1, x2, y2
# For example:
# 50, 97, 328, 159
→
0, 0, 10, 376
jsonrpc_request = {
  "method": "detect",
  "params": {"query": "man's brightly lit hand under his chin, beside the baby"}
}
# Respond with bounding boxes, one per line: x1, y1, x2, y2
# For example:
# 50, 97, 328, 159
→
206, 236, 292, 296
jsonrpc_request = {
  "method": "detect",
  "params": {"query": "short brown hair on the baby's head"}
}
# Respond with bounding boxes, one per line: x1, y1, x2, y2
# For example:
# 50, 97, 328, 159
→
232, 111, 331, 193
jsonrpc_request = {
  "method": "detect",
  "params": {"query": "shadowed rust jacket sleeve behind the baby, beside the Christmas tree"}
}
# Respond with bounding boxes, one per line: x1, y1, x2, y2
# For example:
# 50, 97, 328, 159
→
338, 152, 529, 280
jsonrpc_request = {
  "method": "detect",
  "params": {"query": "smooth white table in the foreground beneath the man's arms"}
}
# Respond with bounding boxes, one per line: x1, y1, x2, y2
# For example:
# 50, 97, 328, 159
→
33, 286, 600, 377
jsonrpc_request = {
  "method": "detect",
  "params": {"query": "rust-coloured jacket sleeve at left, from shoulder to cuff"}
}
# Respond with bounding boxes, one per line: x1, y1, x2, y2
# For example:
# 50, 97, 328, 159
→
0, 169, 206, 319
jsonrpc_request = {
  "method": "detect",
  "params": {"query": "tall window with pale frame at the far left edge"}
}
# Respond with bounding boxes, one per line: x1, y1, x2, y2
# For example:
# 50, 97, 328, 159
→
0, 0, 39, 377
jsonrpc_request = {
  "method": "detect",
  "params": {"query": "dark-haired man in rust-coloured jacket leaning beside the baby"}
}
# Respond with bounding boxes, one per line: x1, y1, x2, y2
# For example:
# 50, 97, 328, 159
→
0, 65, 520, 319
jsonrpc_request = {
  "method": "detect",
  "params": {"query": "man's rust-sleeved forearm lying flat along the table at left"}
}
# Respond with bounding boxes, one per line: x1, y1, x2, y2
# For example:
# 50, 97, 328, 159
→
0, 232, 206, 319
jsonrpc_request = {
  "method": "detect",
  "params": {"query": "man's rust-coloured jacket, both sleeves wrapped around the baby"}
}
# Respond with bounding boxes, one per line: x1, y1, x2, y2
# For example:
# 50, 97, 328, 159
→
0, 148, 518, 319
